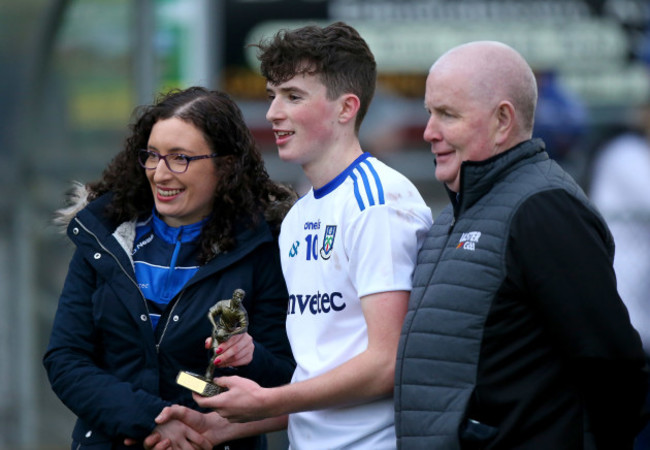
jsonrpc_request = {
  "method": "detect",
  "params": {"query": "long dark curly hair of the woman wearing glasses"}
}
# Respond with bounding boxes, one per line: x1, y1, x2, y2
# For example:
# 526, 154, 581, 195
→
87, 87, 296, 263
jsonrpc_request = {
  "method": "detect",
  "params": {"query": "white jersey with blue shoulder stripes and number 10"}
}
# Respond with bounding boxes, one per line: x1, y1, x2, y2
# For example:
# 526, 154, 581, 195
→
279, 153, 432, 450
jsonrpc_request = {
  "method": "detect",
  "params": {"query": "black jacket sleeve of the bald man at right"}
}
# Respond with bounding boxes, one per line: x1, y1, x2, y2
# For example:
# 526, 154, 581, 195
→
507, 190, 647, 448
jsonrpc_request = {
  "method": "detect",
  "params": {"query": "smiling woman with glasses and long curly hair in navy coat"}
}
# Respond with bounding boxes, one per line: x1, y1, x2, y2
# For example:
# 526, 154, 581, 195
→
44, 87, 295, 450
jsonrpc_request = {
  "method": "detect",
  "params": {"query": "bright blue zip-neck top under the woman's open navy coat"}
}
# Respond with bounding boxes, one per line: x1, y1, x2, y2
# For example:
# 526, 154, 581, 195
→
132, 211, 207, 328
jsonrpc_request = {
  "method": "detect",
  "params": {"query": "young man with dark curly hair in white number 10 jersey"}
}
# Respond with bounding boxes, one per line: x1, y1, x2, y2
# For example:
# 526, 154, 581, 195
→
144, 22, 432, 450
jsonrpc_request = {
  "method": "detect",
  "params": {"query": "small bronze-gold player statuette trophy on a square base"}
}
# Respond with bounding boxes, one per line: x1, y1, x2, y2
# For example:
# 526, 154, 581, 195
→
176, 289, 248, 397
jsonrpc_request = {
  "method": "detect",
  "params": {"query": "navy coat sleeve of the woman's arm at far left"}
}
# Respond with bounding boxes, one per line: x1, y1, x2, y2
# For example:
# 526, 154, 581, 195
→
43, 246, 168, 439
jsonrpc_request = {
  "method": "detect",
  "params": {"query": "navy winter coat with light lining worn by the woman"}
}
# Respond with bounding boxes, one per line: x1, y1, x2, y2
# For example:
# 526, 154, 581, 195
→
44, 192, 295, 449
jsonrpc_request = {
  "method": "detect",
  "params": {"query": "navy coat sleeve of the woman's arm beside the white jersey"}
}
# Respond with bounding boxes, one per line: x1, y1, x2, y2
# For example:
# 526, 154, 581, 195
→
233, 241, 296, 387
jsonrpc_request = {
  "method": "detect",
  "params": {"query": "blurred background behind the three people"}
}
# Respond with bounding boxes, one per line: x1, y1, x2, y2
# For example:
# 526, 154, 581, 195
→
0, 0, 650, 450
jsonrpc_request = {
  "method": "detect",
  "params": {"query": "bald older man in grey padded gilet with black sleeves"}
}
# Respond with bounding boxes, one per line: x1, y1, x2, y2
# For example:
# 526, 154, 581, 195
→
395, 42, 650, 450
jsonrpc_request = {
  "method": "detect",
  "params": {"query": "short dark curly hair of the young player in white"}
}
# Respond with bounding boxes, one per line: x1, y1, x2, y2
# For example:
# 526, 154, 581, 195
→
252, 22, 377, 132
